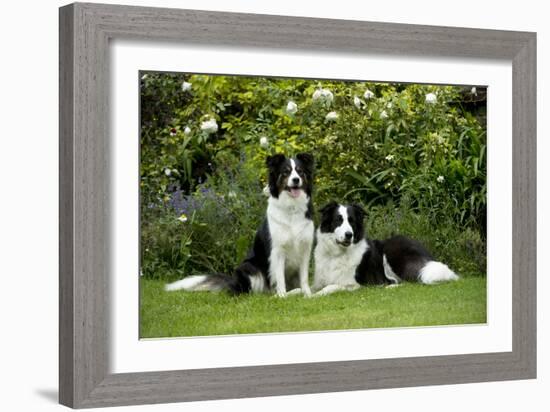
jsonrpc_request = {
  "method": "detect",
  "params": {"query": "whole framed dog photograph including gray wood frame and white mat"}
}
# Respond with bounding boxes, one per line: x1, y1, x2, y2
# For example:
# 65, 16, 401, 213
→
59, 3, 536, 408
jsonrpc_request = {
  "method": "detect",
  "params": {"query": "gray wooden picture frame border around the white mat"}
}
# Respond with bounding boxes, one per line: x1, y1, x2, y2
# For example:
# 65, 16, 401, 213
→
59, 3, 536, 408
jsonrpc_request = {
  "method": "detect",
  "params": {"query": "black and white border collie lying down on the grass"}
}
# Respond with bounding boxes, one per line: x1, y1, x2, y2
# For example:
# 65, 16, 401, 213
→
313, 202, 458, 296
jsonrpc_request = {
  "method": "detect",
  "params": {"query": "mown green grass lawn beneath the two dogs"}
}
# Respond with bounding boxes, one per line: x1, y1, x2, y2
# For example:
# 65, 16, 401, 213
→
140, 277, 487, 338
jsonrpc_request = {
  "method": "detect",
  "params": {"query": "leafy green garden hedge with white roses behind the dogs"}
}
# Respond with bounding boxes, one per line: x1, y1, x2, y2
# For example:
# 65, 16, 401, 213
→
140, 72, 487, 280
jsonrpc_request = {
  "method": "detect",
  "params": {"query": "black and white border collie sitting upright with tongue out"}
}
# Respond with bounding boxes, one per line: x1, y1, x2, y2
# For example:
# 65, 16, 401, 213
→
165, 153, 315, 297
